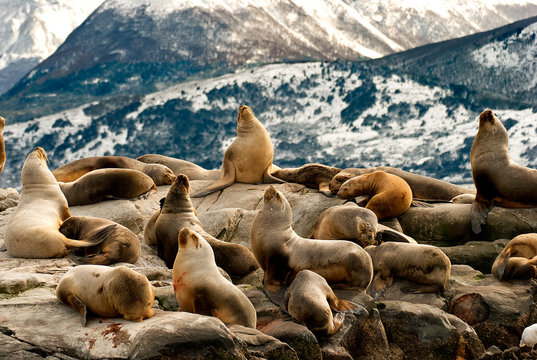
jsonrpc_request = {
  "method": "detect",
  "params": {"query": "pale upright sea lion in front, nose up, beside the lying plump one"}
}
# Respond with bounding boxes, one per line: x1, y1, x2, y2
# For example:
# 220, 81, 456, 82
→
173, 227, 257, 329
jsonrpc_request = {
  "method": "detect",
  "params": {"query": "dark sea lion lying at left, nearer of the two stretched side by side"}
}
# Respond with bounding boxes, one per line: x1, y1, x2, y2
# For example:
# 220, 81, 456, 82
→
59, 168, 157, 206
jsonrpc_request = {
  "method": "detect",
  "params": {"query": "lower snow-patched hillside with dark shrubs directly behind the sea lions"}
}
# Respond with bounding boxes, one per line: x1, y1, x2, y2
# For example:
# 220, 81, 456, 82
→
4, 18, 537, 187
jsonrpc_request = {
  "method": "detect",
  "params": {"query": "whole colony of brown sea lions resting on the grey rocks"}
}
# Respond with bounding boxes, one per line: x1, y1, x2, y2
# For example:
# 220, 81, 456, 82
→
0, 105, 537, 336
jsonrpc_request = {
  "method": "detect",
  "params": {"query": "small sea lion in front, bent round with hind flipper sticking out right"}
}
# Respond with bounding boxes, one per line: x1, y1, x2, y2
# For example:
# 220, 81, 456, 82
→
281, 270, 368, 336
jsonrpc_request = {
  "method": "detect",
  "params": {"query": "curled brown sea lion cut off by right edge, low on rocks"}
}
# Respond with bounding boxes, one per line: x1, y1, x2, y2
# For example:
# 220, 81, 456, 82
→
491, 233, 537, 280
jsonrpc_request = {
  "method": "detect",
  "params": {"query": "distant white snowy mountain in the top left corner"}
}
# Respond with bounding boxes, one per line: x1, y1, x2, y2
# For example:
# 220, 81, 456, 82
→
0, 0, 104, 94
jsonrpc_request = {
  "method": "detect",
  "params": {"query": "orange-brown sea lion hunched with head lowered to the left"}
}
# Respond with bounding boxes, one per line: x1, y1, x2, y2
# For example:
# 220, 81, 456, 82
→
337, 170, 412, 220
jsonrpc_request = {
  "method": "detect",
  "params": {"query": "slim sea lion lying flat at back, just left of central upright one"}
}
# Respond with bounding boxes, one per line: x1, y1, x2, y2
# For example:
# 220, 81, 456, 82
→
137, 154, 221, 180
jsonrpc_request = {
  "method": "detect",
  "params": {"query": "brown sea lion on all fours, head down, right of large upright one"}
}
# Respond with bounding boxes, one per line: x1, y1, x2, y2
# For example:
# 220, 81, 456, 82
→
365, 242, 451, 294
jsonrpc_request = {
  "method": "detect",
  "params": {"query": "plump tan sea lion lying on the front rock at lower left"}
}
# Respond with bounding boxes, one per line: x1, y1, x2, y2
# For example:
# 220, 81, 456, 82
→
56, 265, 155, 326
